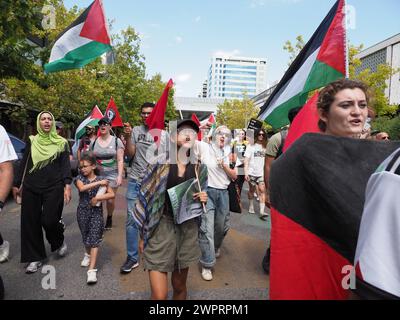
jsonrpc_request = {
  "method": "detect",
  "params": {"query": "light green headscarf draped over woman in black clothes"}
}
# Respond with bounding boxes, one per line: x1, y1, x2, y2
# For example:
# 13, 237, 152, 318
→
29, 111, 68, 172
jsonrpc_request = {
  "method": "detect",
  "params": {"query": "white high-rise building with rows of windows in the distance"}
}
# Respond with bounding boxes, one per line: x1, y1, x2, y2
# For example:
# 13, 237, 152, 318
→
207, 56, 267, 99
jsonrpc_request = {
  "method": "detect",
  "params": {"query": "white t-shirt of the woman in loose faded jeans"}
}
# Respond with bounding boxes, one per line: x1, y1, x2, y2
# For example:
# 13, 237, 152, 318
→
195, 141, 231, 190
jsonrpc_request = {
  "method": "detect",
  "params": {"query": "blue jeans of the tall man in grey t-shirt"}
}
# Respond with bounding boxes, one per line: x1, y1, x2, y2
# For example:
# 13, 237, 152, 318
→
126, 179, 141, 262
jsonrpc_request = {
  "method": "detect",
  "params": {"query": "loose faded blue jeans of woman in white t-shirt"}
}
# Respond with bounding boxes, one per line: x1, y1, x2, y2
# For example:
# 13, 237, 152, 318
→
199, 187, 230, 268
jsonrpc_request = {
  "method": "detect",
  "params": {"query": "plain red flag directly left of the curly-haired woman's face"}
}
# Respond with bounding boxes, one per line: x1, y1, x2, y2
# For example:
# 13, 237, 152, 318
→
283, 92, 320, 151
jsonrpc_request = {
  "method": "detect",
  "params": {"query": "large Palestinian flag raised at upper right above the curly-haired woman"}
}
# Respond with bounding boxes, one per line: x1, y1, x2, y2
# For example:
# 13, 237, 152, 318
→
258, 0, 346, 129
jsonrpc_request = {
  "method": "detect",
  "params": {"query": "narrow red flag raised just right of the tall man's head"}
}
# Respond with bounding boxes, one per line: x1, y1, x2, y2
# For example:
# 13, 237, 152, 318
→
146, 79, 174, 142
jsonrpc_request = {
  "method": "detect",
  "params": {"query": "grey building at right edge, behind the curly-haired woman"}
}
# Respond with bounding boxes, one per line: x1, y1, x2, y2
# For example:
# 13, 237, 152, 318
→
356, 33, 400, 105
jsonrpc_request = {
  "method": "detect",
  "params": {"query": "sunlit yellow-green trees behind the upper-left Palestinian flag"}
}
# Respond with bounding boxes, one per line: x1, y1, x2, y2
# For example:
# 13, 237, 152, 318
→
0, 0, 175, 132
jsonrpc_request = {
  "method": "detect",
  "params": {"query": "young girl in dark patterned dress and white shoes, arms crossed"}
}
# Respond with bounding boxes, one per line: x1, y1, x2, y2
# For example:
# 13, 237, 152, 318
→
75, 154, 115, 284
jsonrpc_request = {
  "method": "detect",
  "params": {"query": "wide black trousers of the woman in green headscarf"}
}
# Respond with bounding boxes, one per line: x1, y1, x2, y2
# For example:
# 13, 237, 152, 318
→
21, 185, 64, 262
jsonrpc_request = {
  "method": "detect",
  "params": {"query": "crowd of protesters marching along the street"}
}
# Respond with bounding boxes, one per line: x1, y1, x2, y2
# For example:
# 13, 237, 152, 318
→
0, 80, 398, 299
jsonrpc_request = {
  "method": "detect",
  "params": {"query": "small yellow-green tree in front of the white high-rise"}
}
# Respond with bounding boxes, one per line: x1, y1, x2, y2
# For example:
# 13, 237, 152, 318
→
216, 95, 260, 129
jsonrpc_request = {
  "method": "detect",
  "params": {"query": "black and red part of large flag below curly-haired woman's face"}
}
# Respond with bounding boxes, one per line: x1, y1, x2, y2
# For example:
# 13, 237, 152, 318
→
270, 133, 400, 300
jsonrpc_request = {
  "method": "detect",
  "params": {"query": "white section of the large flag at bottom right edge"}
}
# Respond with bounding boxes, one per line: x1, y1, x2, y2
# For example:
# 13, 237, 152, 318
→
354, 149, 400, 299
